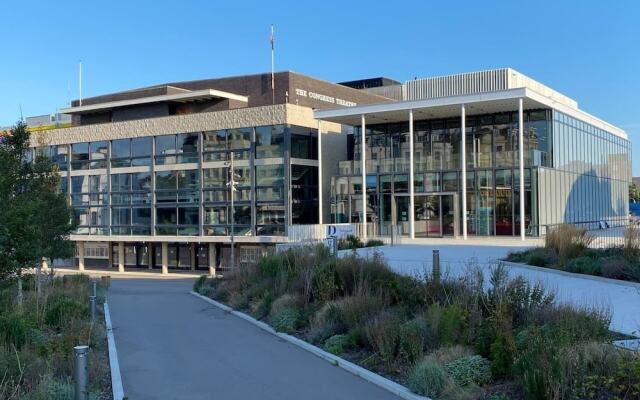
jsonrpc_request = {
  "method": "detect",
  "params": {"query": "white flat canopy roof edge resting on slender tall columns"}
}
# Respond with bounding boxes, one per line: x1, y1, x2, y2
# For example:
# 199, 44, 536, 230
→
314, 88, 627, 139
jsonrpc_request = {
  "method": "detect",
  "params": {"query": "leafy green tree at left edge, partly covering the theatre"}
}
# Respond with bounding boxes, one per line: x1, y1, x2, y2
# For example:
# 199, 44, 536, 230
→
0, 122, 74, 280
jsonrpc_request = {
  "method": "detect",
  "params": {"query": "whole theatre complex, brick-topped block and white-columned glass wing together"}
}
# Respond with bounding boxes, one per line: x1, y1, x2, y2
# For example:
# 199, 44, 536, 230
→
33, 68, 631, 272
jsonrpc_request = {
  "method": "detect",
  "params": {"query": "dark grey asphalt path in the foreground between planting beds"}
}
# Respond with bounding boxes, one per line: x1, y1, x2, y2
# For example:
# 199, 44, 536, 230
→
109, 278, 397, 400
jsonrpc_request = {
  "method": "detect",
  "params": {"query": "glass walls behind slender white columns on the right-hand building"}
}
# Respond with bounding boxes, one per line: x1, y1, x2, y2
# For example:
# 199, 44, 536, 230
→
330, 109, 630, 236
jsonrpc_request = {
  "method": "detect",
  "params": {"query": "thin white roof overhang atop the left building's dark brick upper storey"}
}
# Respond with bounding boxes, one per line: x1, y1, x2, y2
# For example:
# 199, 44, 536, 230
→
60, 89, 249, 114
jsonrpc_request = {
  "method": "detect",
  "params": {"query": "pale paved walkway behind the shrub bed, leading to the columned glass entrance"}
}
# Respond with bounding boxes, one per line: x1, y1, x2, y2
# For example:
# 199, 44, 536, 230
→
350, 244, 640, 336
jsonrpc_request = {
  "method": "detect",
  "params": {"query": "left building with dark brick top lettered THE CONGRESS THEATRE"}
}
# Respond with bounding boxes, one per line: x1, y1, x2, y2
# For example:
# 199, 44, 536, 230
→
33, 72, 390, 272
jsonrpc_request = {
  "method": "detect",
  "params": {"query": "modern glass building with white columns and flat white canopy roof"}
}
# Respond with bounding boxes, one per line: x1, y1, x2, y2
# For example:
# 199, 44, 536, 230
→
315, 68, 631, 239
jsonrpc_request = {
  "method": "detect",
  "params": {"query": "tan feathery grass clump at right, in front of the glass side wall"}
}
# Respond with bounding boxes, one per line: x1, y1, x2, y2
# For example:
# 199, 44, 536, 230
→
544, 224, 593, 265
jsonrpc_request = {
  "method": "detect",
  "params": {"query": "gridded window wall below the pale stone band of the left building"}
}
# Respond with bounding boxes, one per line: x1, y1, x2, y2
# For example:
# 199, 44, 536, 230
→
36, 125, 318, 236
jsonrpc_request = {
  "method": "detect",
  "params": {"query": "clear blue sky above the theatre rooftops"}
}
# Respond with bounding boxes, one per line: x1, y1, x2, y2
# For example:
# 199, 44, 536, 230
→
0, 0, 640, 175
